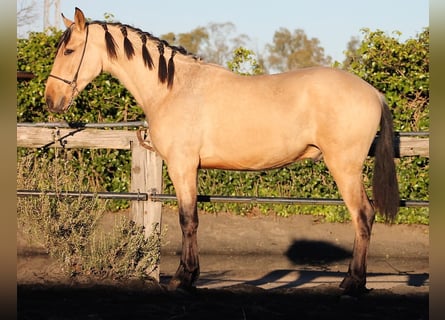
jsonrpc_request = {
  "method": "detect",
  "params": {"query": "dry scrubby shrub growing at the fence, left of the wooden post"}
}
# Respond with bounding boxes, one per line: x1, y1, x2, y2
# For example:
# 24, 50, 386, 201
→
17, 150, 161, 278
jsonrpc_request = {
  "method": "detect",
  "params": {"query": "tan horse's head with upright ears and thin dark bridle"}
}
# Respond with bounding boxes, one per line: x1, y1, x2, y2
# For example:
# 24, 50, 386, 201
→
45, 8, 101, 112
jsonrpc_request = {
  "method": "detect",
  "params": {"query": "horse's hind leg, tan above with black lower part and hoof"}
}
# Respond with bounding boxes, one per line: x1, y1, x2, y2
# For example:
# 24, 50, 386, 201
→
325, 158, 375, 295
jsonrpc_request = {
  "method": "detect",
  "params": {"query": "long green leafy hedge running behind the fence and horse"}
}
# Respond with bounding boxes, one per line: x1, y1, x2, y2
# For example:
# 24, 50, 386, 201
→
17, 29, 429, 223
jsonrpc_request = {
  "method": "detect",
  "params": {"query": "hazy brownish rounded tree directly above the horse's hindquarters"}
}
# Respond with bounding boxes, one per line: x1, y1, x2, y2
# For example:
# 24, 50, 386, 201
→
266, 28, 332, 72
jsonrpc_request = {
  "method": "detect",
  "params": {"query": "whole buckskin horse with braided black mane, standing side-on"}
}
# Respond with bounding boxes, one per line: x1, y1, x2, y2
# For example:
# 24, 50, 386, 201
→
45, 8, 399, 295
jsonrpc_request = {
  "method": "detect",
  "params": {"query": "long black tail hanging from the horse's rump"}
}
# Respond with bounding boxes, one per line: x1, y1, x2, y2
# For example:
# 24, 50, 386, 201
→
372, 96, 400, 222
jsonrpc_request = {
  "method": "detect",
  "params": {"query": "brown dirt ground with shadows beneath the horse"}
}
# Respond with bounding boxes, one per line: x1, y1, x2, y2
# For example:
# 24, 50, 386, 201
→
17, 209, 429, 320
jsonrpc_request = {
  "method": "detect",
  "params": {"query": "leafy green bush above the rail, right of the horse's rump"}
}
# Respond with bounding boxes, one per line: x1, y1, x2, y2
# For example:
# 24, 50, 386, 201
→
348, 28, 429, 131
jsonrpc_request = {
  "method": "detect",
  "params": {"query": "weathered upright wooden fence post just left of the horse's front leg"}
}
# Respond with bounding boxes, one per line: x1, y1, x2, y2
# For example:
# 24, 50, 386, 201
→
130, 139, 162, 281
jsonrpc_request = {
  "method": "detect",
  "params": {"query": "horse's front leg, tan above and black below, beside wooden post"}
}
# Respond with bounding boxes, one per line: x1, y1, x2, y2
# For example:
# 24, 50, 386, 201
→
168, 164, 199, 290
